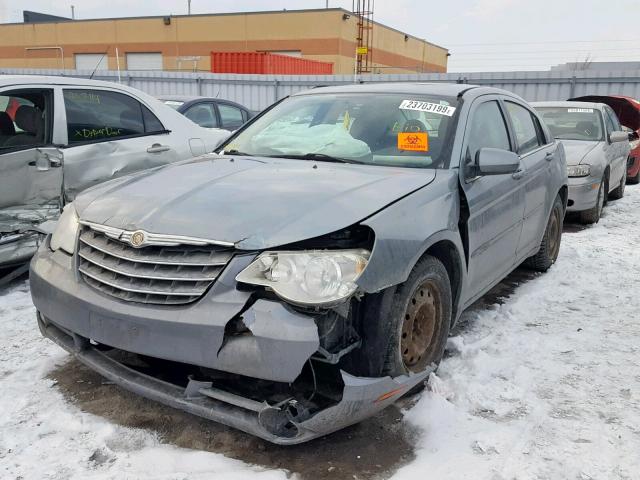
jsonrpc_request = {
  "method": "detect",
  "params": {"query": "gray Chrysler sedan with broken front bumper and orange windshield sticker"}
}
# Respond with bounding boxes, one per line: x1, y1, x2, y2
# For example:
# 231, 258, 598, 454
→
31, 84, 567, 444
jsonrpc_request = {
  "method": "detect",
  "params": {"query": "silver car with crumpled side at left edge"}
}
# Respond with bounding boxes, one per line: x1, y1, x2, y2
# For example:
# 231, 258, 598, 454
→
0, 75, 228, 266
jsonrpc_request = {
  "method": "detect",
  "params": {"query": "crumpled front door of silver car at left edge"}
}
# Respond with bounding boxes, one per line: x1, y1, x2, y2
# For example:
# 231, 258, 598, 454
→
0, 85, 62, 248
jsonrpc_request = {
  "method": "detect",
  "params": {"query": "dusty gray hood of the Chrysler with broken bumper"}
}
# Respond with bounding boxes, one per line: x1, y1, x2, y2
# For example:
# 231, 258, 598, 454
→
75, 155, 436, 250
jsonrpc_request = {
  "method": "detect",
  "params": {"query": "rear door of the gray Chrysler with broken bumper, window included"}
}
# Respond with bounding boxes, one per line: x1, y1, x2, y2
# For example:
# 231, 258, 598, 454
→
504, 99, 554, 259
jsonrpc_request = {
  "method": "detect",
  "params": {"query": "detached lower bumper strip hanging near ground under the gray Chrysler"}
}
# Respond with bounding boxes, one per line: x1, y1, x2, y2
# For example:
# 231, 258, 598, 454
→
38, 315, 432, 445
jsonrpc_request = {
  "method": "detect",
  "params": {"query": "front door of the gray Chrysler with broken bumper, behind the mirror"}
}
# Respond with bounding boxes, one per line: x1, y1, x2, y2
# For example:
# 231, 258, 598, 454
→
460, 95, 525, 301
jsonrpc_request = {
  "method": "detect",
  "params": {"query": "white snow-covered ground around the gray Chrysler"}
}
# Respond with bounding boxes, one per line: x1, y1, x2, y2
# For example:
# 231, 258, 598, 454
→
0, 187, 640, 480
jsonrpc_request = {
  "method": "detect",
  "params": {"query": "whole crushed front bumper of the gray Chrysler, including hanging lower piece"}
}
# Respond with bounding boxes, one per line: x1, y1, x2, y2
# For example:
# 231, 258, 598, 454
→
31, 240, 433, 445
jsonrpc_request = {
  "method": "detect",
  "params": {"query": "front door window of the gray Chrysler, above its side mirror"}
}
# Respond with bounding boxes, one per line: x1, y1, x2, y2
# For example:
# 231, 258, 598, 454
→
467, 100, 511, 164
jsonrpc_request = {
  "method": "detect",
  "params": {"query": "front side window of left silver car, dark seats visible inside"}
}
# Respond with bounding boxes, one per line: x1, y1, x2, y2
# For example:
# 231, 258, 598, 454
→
0, 90, 52, 150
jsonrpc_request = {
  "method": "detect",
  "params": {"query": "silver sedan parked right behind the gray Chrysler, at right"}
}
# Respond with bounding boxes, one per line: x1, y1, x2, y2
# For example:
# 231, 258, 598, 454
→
531, 102, 631, 224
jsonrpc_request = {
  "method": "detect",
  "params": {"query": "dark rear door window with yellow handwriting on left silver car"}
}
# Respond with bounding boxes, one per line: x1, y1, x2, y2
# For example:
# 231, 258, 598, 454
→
64, 90, 151, 144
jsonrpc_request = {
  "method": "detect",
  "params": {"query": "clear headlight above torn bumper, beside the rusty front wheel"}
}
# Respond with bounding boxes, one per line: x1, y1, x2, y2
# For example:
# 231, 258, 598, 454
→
236, 249, 370, 306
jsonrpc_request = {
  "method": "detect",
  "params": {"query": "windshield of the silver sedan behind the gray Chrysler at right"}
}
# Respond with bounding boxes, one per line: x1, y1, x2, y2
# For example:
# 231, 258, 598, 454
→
536, 107, 604, 141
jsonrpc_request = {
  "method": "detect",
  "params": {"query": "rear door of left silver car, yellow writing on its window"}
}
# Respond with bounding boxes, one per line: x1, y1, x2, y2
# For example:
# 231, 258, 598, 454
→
62, 86, 180, 200
